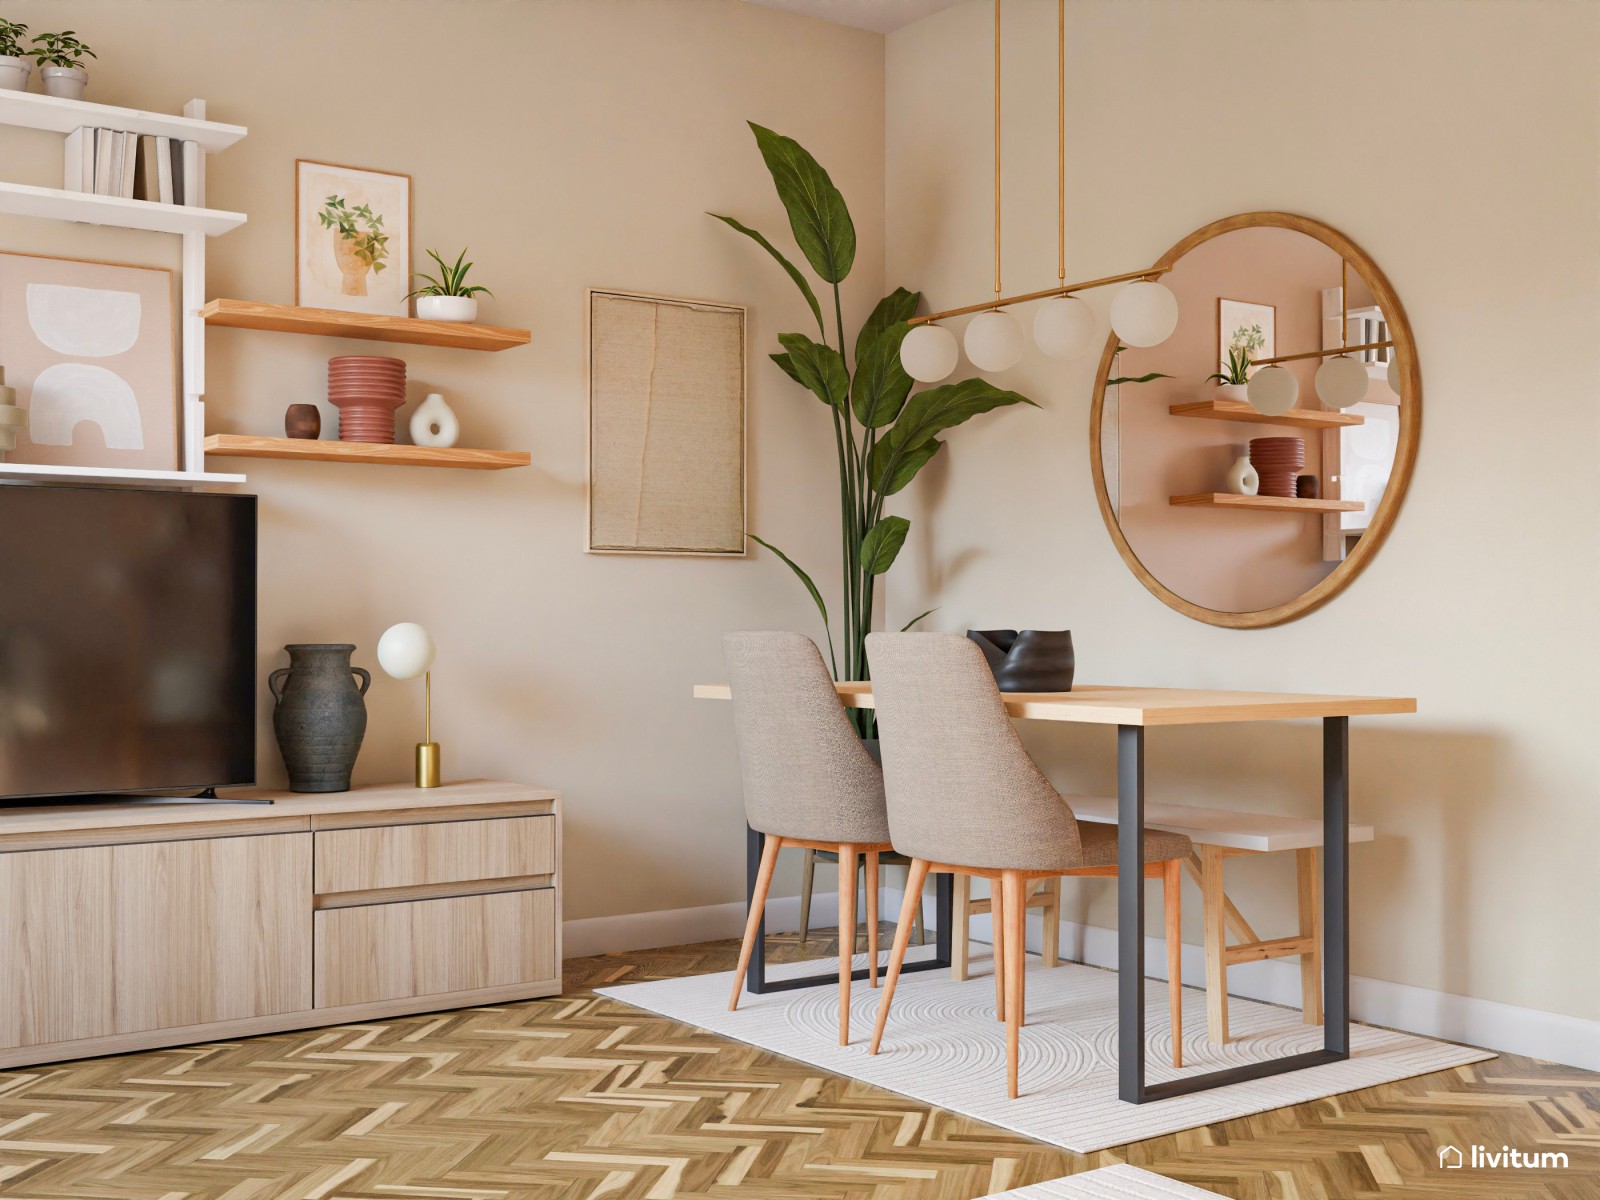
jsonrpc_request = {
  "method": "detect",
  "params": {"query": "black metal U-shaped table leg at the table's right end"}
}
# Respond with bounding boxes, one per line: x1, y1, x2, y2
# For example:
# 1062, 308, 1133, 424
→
1117, 717, 1350, 1104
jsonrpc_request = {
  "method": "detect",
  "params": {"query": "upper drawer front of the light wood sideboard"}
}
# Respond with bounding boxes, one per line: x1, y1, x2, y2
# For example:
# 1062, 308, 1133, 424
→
315, 816, 555, 894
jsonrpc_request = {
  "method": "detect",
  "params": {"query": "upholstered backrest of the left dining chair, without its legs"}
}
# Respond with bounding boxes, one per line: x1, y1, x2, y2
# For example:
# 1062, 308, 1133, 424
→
722, 632, 890, 843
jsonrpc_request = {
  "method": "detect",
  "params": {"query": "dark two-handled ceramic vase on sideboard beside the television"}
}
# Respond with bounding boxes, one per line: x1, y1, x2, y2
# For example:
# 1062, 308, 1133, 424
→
267, 645, 373, 792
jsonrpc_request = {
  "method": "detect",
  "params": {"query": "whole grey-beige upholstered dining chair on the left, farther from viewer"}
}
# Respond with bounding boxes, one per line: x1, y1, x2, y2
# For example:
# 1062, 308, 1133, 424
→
722, 632, 910, 1046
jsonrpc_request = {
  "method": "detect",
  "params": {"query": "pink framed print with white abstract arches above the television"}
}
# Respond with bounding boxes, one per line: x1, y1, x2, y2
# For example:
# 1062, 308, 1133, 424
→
0, 253, 179, 470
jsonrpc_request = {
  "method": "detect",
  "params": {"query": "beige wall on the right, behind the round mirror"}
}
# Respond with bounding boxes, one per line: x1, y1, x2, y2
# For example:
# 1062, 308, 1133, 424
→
886, 0, 1600, 1018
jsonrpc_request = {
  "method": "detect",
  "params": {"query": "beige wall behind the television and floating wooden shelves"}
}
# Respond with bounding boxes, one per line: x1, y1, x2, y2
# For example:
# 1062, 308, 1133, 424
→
0, 0, 883, 918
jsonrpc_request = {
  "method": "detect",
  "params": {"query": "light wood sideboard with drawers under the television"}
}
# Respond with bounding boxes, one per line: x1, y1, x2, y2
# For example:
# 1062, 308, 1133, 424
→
0, 779, 562, 1067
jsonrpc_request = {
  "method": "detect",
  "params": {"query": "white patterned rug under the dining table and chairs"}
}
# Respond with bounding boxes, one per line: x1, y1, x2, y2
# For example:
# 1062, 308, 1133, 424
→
598, 947, 1494, 1154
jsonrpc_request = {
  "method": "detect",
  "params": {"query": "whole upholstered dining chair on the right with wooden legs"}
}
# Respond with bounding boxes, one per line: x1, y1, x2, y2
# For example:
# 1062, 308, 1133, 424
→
867, 634, 1190, 1099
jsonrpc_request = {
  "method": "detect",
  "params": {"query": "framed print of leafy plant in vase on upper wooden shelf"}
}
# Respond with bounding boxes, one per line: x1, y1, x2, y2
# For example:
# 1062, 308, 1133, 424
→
294, 158, 411, 317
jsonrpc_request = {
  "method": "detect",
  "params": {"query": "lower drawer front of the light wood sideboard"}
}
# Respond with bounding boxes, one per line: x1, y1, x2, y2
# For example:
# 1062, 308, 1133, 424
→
314, 888, 555, 1008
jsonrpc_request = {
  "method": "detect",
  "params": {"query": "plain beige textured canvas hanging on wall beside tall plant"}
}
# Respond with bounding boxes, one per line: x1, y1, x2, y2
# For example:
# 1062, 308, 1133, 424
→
587, 288, 746, 557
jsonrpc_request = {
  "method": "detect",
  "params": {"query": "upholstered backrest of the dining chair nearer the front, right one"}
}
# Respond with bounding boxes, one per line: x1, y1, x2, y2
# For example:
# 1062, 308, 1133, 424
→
867, 634, 1082, 870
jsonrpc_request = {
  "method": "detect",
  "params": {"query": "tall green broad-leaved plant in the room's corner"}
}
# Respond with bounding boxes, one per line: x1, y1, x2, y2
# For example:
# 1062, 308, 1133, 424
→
710, 122, 1034, 678
